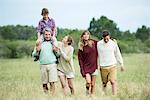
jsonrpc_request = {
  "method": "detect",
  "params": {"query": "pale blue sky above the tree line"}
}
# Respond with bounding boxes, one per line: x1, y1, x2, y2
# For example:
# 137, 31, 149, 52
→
0, 0, 150, 32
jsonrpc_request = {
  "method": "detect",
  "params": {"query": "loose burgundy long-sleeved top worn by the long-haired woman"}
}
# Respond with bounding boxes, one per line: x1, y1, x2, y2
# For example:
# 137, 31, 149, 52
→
78, 40, 98, 77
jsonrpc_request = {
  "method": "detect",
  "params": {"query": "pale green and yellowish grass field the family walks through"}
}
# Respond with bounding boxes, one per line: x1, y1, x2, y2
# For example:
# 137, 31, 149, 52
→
0, 54, 150, 100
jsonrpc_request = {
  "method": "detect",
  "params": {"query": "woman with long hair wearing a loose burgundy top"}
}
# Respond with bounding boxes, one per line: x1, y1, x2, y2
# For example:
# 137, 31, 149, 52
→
78, 31, 98, 95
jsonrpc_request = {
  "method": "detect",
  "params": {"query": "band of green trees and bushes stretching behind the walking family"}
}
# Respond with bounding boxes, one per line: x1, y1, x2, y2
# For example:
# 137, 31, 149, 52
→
0, 16, 150, 58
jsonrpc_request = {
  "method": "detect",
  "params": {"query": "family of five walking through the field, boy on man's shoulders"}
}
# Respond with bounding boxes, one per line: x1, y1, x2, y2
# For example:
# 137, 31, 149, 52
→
32, 8, 124, 96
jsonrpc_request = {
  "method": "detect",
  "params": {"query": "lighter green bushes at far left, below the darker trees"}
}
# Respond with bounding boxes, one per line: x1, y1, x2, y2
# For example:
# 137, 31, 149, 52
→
0, 40, 34, 58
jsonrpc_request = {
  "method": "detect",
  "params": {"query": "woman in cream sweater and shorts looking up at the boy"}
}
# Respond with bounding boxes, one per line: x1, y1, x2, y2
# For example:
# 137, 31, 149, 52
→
54, 36, 75, 95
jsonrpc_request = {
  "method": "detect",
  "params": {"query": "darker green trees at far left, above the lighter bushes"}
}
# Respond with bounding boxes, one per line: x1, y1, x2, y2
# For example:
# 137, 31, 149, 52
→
0, 25, 36, 40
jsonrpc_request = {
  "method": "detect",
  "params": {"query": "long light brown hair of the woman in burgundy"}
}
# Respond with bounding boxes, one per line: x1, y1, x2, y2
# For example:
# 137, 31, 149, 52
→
79, 30, 94, 51
